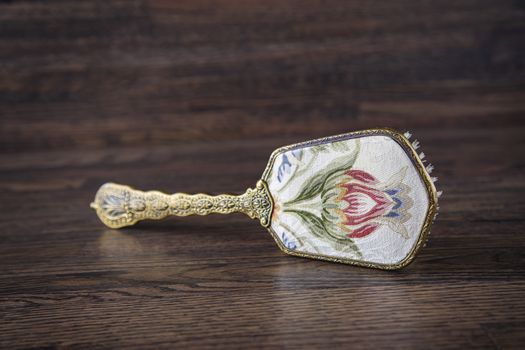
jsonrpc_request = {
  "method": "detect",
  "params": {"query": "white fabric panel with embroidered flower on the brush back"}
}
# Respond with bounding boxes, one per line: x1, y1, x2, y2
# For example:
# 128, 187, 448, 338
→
266, 135, 429, 264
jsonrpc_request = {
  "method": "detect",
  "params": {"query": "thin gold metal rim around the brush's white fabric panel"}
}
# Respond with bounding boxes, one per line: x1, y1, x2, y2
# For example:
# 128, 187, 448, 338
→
262, 128, 438, 270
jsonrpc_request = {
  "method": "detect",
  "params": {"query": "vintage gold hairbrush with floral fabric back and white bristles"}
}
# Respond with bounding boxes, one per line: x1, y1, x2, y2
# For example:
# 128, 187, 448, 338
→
91, 129, 438, 269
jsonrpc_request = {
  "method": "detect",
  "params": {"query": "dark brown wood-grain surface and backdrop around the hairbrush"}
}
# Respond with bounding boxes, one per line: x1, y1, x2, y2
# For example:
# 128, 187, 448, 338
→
0, 0, 525, 349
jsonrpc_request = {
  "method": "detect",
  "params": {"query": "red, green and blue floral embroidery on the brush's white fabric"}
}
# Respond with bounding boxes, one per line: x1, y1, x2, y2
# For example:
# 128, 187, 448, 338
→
274, 140, 413, 258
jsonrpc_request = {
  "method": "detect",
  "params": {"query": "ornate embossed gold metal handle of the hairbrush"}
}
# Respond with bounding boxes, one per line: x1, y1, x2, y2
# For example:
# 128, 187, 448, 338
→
91, 180, 273, 228
